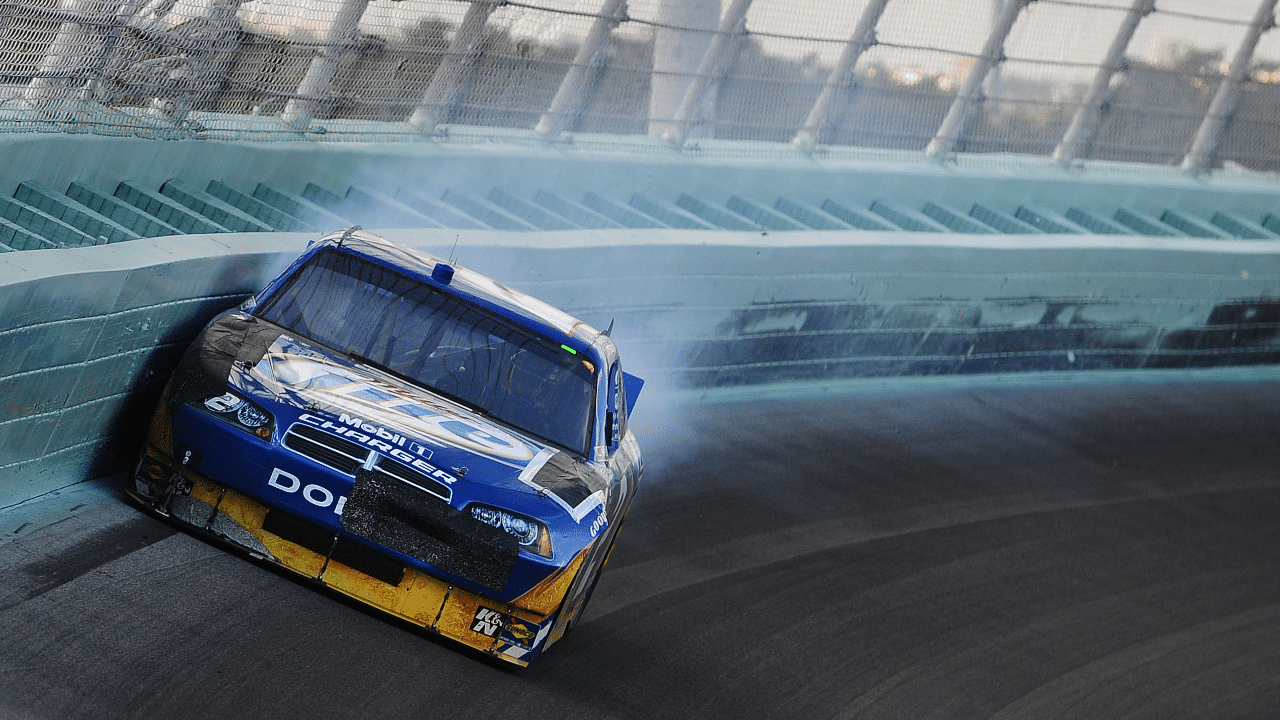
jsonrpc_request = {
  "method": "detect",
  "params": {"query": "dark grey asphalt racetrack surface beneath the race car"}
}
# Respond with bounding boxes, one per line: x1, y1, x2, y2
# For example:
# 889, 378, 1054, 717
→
0, 378, 1280, 720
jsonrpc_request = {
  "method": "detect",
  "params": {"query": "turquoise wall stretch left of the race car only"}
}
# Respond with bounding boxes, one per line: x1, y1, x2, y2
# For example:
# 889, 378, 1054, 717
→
0, 229, 305, 506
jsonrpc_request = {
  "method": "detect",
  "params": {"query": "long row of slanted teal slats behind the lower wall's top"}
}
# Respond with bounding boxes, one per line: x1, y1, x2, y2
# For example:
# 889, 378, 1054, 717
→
0, 178, 1280, 251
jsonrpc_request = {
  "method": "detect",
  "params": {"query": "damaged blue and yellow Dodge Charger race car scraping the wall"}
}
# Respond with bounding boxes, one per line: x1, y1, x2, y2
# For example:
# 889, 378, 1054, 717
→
128, 228, 643, 665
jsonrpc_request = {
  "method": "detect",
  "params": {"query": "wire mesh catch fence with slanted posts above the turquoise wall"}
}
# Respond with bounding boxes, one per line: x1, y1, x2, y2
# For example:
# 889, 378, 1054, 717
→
0, 0, 1280, 170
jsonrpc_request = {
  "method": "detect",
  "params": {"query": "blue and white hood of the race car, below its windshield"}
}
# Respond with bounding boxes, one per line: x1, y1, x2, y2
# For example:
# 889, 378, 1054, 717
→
175, 313, 608, 521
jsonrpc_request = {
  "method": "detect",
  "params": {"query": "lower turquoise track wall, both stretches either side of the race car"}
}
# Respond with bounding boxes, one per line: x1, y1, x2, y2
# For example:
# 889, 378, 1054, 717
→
0, 231, 1280, 507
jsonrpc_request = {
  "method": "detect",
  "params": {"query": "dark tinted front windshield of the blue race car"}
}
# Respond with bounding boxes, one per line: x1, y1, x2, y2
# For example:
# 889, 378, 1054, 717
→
256, 250, 595, 455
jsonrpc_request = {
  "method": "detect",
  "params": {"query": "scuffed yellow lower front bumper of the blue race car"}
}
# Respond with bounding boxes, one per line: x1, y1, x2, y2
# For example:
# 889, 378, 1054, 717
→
127, 447, 588, 666
